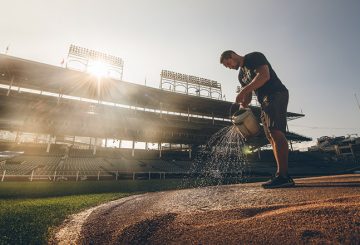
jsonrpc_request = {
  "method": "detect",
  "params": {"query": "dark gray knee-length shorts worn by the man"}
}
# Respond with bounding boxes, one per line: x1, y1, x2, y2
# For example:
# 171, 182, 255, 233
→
261, 91, 289, 138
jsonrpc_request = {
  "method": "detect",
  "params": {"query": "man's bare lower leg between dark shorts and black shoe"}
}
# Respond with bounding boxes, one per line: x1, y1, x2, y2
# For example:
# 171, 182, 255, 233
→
270, 129, 289, 177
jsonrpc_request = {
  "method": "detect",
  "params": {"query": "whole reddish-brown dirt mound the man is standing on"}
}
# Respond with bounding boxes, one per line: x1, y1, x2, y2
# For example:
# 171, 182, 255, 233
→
52, 175, 360, 244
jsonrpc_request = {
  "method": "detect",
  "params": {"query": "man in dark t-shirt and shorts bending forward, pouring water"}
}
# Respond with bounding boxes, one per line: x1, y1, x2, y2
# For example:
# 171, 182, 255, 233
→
220, 50, 295, 188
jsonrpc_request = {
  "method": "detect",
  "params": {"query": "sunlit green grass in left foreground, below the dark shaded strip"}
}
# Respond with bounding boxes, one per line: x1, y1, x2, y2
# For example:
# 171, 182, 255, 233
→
0, 193, 127, 244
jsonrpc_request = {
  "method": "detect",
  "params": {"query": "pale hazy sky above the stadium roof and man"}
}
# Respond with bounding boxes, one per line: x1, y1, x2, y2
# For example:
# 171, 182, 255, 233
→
0, 0, 360, 147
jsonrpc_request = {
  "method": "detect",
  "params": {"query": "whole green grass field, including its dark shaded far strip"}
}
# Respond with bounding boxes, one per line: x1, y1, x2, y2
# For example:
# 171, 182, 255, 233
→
0, 180, 183, 244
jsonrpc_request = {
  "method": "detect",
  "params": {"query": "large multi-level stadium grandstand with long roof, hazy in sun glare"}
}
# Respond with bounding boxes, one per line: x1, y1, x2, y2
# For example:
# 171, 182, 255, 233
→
0, 54, 310, 181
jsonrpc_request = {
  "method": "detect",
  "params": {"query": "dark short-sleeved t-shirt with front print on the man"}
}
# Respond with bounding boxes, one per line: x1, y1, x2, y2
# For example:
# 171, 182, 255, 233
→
238, 52, 287, 103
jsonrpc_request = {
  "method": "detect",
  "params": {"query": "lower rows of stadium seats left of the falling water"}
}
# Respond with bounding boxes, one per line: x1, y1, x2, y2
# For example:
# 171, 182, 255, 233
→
0, 151, 190, 180
